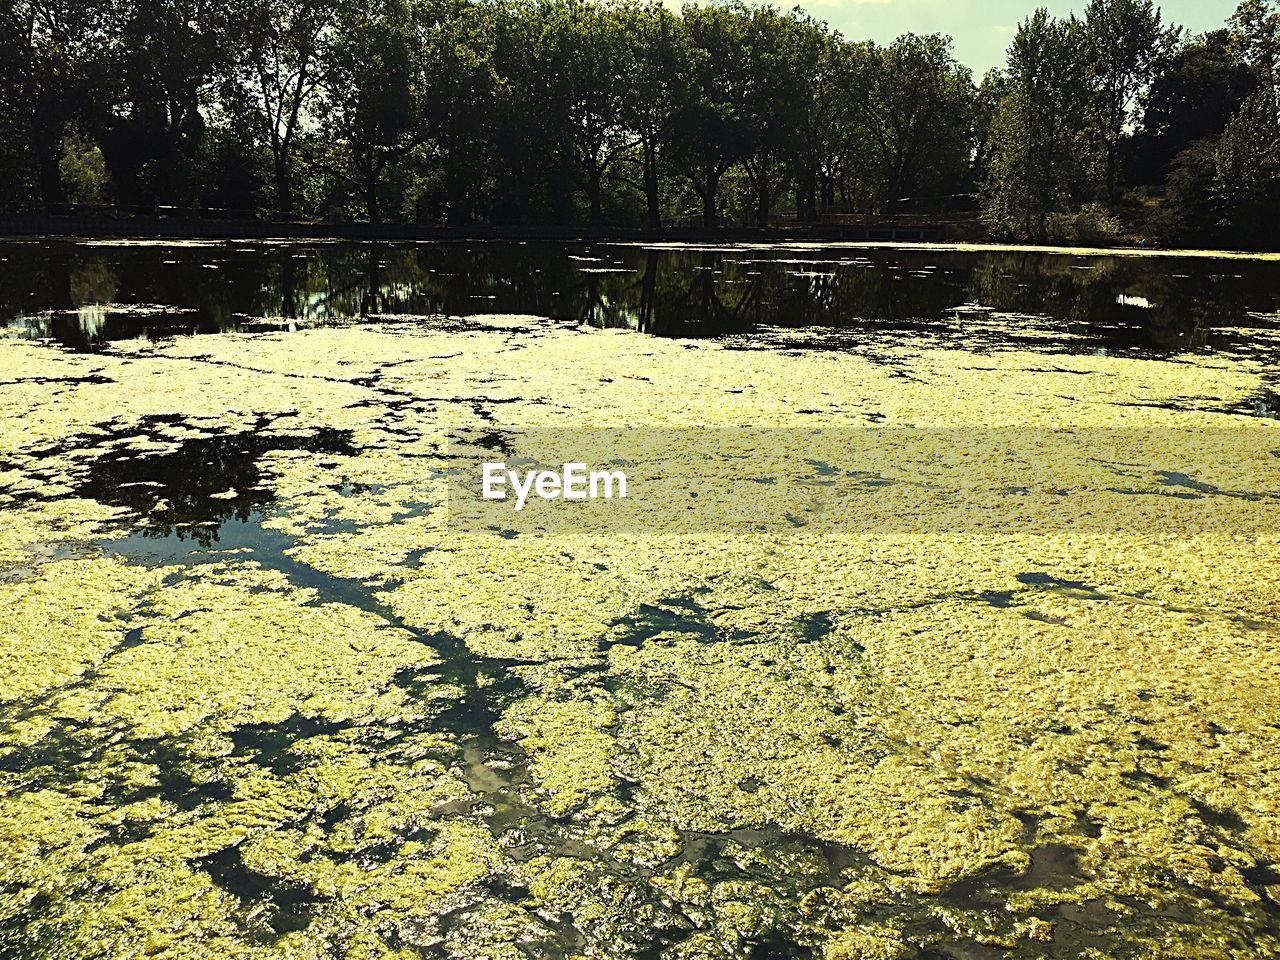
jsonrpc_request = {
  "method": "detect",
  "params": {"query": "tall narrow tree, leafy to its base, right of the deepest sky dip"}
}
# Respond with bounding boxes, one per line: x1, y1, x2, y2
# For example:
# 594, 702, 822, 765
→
984, 8, 1089, 239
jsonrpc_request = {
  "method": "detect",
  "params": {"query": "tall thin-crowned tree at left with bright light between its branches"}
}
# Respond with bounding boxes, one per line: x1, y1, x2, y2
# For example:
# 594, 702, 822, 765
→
224, 0, 337, 218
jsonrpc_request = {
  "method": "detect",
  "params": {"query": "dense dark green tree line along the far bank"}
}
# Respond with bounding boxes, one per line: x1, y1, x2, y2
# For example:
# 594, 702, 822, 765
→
0, 0, 1280, 242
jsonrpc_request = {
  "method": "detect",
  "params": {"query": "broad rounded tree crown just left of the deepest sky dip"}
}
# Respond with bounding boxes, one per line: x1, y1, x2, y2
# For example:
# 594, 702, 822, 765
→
844, 33, 974, 209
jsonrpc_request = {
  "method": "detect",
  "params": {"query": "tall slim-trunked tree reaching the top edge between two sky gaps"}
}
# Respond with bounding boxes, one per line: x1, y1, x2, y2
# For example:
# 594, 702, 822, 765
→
1084, 0, 1178, 200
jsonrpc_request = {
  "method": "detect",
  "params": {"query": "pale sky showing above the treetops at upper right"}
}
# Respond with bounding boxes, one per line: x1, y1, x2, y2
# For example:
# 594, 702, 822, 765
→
757, 0, 1238, 79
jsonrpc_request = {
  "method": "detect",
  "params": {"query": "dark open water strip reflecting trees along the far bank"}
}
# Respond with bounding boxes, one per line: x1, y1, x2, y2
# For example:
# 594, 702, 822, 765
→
0, 241, 1280, 363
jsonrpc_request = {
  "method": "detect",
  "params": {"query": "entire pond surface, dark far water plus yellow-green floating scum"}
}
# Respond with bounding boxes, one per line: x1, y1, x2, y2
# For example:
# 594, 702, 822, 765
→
0, 236, 1280, 960
